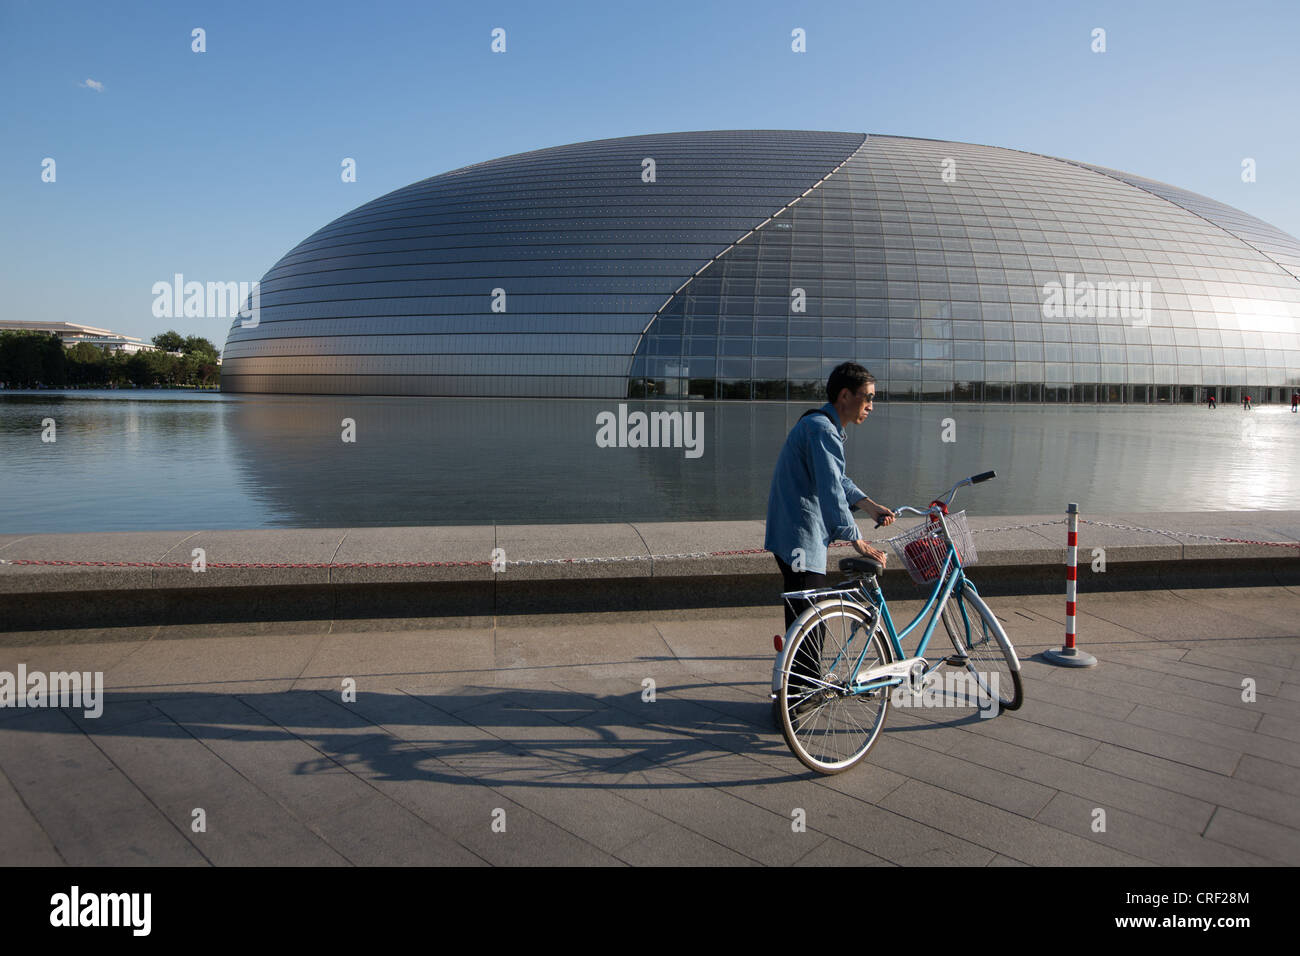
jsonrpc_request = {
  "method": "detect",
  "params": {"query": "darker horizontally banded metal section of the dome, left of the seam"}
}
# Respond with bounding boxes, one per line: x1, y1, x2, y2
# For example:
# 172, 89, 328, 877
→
222, 130, 863, 398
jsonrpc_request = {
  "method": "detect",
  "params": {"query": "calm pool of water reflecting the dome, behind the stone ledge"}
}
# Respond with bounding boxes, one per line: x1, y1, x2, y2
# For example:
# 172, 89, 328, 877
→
0, 390, 1300, 533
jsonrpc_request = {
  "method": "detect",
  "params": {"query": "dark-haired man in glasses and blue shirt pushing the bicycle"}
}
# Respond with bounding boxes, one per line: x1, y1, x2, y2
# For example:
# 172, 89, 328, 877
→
763, 362, 894, 630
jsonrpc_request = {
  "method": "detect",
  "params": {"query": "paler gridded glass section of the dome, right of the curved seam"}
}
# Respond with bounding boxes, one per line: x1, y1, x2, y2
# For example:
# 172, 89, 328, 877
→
628, 137, 1300, 402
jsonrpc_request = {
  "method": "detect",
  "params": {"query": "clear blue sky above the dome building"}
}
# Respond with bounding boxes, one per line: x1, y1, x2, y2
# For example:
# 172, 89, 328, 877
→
0, 0, 1300, 347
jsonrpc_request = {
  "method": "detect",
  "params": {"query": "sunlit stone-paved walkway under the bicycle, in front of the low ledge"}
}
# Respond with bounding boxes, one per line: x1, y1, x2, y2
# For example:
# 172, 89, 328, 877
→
0, 588, 1300, 866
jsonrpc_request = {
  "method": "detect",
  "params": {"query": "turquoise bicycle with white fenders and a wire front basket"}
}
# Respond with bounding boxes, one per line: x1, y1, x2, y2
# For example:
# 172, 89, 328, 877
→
772, 471, 1024, 774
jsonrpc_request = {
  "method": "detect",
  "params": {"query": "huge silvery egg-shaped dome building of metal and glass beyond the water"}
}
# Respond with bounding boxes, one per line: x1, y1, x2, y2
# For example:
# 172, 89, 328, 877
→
222, 130, 1300, 402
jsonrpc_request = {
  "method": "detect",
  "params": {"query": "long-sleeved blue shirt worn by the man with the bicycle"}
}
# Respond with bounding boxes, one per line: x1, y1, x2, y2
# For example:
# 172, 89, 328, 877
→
763, 402, 867, 574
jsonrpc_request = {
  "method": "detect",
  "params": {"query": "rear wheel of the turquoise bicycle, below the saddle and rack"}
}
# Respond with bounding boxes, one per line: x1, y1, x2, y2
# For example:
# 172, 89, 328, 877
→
777, 601, 891, 774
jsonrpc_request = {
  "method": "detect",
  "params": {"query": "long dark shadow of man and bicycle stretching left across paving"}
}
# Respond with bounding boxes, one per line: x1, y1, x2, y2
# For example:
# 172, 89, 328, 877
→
0, 683, 821, 790
